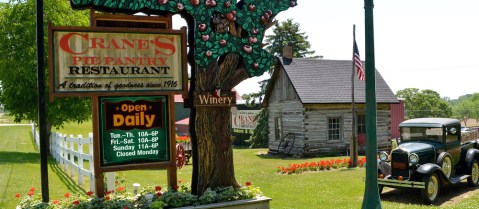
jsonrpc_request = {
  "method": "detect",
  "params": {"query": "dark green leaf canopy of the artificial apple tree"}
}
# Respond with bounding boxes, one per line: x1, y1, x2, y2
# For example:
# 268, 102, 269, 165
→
71, 0, 296, 76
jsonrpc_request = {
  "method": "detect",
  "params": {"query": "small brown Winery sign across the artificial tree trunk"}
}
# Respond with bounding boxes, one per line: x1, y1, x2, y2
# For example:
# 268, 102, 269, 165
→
194, 92, 236, 107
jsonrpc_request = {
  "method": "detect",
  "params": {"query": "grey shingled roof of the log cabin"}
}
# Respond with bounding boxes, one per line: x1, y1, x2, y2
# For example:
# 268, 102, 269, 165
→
266, 58, 399, 104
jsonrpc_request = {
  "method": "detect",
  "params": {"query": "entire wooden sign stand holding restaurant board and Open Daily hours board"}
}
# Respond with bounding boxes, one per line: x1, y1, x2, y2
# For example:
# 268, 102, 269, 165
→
48, 17, 188, 197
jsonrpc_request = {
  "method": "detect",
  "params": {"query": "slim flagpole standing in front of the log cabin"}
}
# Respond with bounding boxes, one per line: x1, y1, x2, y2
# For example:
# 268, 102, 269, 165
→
349, 24, 358, 167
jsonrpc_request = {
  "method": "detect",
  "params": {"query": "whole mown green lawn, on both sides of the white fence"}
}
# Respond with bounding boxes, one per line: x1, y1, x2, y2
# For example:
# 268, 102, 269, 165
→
0, 123, 479, 209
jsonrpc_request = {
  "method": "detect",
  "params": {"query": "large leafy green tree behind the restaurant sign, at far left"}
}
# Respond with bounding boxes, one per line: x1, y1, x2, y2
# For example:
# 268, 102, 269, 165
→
0, 0, 91, 134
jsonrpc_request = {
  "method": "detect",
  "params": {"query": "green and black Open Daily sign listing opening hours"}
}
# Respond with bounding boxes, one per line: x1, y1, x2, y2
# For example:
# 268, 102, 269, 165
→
100, 96, 170, 166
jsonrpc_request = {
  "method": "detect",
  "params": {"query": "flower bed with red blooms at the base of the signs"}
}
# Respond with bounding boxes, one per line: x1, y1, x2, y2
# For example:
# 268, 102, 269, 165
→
15, 182, 262, 209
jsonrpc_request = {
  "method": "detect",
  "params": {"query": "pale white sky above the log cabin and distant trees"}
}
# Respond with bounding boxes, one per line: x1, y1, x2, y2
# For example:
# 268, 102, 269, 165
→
4, 0, 479, 99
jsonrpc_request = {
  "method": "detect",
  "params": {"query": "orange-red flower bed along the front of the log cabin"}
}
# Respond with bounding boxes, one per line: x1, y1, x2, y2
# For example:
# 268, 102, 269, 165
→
276, 158, 366, 174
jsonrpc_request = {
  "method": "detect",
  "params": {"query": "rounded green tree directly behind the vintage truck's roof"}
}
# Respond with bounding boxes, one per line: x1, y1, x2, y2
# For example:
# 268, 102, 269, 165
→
396, 88, 452, 119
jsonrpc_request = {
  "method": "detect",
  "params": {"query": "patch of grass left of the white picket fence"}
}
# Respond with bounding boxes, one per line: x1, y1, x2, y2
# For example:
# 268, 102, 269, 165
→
0, 126, 84, 208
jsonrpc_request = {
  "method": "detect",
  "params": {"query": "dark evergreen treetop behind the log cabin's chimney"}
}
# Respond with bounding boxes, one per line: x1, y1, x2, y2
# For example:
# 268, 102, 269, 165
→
265, 19, 315, 58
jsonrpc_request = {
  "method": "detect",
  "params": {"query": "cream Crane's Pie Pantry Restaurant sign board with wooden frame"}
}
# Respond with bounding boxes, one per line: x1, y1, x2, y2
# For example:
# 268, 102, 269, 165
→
49, 27, 187, 97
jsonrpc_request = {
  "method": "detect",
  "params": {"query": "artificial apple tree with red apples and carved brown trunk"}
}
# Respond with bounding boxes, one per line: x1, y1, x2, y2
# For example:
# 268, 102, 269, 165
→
70, 0, 296, 194
